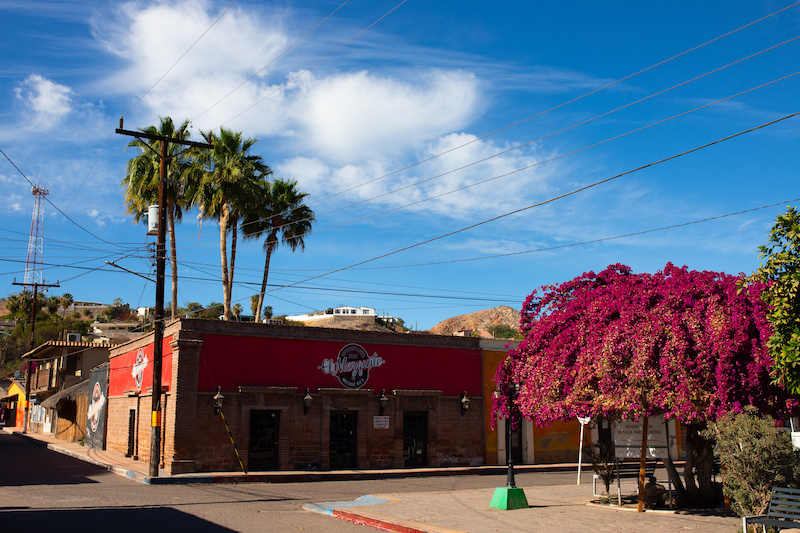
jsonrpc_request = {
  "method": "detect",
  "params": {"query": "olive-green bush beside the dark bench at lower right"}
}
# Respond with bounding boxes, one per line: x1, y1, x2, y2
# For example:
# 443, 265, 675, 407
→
703, 407, 800, 516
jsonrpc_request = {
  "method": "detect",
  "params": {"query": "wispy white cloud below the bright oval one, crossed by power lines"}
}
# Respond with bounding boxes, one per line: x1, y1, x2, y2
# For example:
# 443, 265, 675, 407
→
275, 133, 556, 219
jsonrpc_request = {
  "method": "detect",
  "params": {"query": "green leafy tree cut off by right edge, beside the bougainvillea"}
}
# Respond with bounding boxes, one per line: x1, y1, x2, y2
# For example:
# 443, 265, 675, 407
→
752, 207, 800, 394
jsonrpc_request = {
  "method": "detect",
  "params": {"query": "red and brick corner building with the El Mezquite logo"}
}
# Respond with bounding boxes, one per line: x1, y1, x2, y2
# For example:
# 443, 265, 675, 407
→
107, 319, 486, 474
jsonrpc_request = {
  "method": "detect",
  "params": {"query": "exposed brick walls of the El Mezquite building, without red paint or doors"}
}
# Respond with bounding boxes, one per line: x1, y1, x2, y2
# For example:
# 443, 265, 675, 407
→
107, 320, 485, 474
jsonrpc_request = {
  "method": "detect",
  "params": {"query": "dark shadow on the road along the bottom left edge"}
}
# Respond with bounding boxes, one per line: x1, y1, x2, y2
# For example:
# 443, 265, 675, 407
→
0, 507, 234, 533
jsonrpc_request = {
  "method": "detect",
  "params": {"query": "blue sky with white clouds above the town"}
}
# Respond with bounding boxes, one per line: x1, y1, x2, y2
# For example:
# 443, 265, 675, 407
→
0, 0, 800, 329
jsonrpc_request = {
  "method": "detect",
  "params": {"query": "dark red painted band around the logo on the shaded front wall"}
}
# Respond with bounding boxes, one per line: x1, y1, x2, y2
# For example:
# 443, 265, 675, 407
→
195, 335, 483, 396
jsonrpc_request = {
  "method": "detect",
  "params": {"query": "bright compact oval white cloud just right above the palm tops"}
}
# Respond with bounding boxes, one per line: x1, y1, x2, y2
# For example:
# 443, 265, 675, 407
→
289, 70, 479, 162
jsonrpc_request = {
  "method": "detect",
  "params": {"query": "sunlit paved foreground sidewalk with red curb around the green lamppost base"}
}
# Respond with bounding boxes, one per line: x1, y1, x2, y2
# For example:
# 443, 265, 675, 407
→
306, 482, 741, 533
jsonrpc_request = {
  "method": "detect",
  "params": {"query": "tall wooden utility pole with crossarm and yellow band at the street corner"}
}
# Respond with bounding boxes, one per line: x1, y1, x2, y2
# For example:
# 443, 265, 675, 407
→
116, 118, 211, 477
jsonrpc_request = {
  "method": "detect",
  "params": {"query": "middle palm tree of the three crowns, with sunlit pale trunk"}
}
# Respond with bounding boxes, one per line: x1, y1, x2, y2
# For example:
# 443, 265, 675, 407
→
194, 128, 272, 320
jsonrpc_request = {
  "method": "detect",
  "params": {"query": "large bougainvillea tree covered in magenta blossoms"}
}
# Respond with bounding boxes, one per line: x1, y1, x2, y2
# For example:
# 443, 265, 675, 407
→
494, 264, 787, 505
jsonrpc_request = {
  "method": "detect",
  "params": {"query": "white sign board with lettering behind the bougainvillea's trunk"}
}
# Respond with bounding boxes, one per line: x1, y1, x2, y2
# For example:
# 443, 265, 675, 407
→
611, 415, 678, 459
